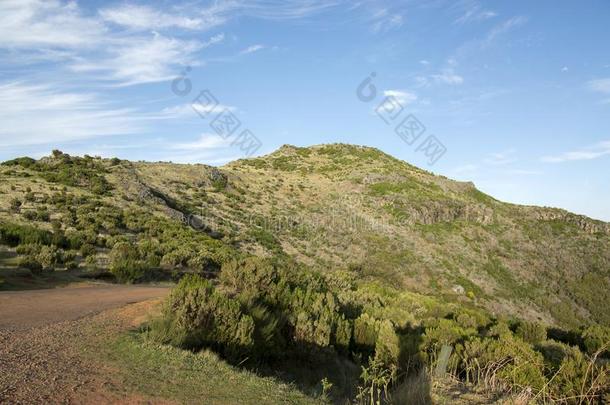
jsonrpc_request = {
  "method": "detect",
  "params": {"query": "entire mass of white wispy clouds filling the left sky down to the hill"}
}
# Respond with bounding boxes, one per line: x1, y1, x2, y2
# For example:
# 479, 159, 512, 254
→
0, 0, 346, 150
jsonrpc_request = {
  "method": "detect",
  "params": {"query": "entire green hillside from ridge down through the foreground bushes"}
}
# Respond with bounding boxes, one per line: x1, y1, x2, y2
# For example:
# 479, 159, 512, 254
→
0, 144, 610, 403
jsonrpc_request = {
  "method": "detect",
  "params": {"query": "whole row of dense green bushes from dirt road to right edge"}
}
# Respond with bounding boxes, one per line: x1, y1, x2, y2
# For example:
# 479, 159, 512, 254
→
149, 254, 609, 403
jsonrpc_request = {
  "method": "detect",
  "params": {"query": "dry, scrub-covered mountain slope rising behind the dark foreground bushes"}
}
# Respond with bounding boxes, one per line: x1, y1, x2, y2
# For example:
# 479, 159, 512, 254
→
0, 144, 610, 327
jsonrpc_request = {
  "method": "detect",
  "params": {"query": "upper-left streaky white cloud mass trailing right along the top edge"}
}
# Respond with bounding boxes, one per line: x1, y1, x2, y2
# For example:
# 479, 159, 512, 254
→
0, 0, 338, 86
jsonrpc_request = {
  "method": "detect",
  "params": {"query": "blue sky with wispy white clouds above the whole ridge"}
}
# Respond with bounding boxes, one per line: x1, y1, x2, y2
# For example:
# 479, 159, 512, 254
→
0, 0, 610, 220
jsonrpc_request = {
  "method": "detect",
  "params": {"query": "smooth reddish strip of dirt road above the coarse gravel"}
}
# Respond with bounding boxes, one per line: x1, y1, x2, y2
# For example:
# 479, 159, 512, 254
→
0, 284, 168, 330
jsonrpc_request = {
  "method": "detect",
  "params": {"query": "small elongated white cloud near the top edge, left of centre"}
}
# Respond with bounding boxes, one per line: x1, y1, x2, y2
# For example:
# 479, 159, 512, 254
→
99, 4, 205, 30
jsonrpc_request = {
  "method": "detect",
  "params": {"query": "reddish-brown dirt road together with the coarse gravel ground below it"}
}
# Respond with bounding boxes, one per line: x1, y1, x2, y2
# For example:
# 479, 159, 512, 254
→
0, 285, 169, 404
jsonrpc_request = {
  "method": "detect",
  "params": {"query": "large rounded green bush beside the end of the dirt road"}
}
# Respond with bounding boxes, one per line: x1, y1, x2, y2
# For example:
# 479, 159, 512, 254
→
150, 258, 364, 358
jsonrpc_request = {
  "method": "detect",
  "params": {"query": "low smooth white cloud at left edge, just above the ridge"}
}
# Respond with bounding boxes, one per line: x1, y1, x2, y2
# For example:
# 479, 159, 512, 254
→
0, 82, 150, 147
